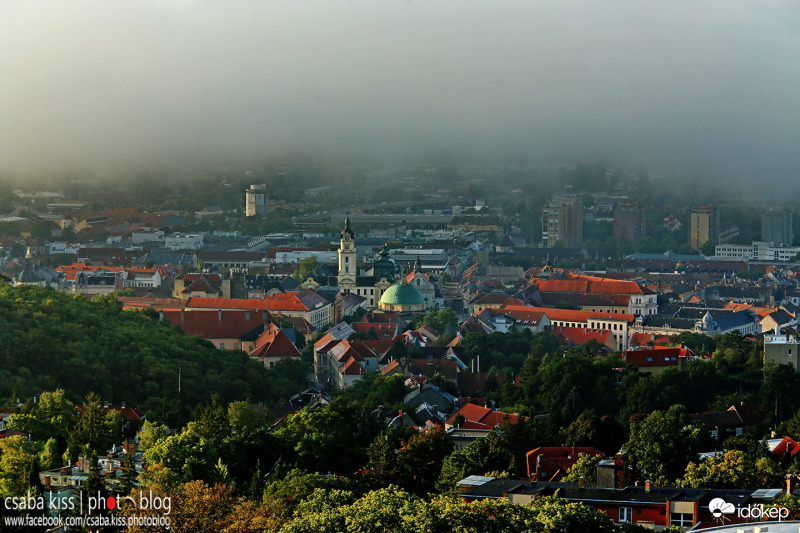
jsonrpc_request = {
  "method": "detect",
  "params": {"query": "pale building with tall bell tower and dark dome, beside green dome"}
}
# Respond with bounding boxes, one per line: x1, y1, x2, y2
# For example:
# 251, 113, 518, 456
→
337, 213, 398, 309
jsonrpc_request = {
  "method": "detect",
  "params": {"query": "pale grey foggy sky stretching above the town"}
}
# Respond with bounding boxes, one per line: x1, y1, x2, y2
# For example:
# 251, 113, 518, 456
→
0, 0, 800, 181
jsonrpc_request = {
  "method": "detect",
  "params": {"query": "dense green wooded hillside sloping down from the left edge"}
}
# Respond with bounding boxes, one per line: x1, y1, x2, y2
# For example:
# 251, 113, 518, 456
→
0, 285, 305, 422
